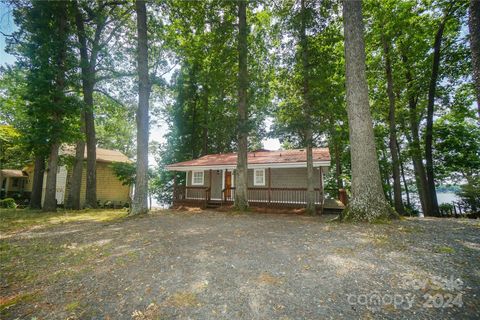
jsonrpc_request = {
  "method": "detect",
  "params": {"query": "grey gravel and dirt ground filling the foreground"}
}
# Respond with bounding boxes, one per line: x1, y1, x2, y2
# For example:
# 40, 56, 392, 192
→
0, 210, 480, 319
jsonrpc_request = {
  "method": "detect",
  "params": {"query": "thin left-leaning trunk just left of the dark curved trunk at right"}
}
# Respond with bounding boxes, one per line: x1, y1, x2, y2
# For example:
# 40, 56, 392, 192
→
402, 54, 430, 217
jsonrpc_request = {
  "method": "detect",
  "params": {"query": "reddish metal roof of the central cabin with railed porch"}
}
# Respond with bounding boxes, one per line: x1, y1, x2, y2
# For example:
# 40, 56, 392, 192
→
167, 148, 330, 168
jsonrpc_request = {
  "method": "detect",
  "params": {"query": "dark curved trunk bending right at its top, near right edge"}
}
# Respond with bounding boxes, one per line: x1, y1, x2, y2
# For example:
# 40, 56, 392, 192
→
425, 15, 448, 216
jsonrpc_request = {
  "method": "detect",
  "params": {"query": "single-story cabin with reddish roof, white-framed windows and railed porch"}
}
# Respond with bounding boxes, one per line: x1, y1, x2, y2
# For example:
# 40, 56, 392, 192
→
167, 148, 330, 210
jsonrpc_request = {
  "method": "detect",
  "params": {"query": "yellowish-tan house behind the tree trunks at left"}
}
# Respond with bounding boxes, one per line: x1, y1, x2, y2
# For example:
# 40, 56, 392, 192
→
0, 146, 131, 207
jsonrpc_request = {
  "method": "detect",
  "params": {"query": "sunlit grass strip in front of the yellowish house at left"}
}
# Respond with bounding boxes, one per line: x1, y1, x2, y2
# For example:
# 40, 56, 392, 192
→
0, 209, 127, 233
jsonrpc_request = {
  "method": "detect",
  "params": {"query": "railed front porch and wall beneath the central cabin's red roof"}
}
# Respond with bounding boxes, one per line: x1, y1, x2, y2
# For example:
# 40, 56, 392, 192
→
173, 167, 324, 211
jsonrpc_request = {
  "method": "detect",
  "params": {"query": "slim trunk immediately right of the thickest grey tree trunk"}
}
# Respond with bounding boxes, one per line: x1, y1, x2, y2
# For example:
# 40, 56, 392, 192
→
382, 36, 405, 215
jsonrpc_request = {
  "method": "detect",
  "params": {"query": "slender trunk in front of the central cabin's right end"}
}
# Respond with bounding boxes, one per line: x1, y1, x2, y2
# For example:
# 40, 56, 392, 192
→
300, 0, 315, 214
